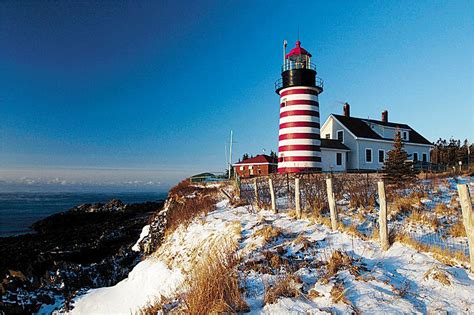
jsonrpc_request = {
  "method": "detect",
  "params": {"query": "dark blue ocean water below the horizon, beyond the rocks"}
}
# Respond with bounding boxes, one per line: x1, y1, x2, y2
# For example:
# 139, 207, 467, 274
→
0, 192, 167, 237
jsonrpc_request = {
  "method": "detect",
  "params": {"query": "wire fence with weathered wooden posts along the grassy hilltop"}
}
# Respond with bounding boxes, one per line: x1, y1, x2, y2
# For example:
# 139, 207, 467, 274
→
239, 173, 474, 272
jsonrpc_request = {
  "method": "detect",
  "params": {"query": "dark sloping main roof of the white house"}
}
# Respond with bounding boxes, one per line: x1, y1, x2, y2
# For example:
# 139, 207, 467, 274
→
332, 114, 431, 145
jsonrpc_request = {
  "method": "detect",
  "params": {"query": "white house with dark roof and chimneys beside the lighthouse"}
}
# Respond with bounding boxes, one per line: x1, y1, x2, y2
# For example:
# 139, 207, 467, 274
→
320, 103, 433, 172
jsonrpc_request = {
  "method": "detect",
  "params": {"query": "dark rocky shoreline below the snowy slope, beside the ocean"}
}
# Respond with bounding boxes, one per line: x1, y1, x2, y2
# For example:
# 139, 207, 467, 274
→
0, 200, 164, 314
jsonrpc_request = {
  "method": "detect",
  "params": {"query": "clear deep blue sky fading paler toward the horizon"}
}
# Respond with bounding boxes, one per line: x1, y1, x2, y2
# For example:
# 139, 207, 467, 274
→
0, 0, 474, 191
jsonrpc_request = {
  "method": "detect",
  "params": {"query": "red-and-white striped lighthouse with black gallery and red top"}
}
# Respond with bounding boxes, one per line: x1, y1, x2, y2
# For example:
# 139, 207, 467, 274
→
275, 40, 323, 173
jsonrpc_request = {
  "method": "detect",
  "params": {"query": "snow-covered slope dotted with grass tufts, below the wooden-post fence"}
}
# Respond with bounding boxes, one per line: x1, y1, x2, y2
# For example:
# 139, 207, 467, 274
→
72, 183, 474, 314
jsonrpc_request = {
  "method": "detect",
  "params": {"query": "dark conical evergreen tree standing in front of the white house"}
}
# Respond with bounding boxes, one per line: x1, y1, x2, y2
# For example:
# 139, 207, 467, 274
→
383, 132, 416, 185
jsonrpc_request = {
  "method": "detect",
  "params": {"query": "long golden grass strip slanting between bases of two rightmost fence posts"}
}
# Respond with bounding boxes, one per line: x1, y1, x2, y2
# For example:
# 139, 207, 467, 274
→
395, 233, 469, 266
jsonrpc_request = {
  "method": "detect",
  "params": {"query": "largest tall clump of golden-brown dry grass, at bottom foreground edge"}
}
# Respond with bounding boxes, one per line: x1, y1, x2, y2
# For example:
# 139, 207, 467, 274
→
183, 242, 249, 314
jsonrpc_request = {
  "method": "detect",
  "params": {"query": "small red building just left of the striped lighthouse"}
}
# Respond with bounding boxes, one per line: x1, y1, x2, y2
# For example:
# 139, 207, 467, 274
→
233, 154, 278, 178
